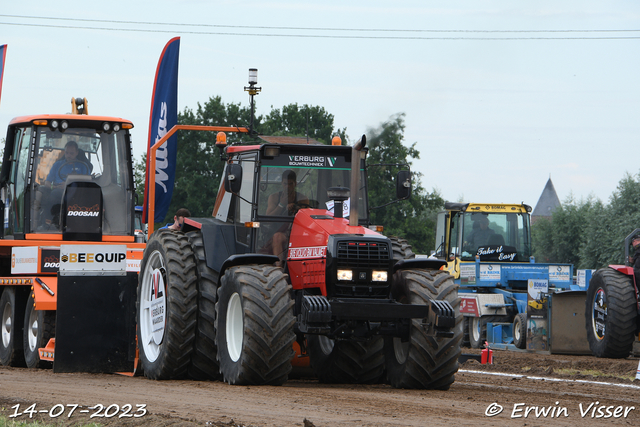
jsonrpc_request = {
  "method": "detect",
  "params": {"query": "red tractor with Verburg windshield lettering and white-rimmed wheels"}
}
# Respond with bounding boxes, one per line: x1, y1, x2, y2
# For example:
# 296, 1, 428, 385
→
137, 137, 462, 390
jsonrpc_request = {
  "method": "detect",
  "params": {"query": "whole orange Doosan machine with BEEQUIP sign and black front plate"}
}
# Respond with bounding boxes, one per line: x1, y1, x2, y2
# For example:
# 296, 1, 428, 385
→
0, 98, 145, 372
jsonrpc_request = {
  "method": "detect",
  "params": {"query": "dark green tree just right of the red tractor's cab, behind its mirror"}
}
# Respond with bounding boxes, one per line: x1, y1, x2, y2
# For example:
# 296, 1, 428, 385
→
367, 113, 444, 253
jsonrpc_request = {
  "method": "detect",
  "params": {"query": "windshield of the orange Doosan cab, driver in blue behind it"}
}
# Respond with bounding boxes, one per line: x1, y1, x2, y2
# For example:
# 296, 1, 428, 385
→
31, 126, 132, 235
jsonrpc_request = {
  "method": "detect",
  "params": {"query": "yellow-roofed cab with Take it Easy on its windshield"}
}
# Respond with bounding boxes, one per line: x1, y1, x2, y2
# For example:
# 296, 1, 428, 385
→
435, 203, 531, 263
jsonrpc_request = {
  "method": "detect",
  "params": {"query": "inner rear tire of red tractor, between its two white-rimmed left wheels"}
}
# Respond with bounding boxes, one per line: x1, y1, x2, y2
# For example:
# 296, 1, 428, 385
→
187, 231, 220, 381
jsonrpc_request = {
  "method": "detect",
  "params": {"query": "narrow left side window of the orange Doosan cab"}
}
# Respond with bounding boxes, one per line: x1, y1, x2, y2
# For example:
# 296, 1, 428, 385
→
10, 127, 31, 233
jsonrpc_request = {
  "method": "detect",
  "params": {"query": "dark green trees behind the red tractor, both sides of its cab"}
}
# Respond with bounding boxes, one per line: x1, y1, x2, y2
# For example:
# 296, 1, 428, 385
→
134, 96, 444, 253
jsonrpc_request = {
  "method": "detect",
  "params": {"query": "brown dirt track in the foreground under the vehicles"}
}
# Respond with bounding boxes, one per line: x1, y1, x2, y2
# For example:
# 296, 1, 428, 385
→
0, 349, 640, 427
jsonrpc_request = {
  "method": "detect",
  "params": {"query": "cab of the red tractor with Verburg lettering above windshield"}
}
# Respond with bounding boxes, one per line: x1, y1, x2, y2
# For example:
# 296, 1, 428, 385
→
214, 144, 369, 254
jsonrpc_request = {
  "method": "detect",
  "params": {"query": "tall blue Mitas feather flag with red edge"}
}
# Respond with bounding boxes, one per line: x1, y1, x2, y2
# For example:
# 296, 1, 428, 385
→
143, 37, 180, 222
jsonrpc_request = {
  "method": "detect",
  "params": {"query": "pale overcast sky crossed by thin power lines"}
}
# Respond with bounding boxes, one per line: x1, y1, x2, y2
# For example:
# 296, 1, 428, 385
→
0, 0, 640, 207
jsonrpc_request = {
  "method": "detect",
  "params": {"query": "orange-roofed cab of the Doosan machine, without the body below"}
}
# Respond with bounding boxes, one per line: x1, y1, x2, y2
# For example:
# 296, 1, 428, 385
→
0, 115, 133, 241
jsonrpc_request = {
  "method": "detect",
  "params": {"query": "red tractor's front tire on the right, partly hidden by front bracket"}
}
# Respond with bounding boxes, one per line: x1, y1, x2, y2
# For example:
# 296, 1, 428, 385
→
385, 269, 463, 390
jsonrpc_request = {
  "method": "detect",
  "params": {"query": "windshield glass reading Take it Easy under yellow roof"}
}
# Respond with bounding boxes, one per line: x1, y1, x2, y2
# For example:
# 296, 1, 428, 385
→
456, 212, 531, 262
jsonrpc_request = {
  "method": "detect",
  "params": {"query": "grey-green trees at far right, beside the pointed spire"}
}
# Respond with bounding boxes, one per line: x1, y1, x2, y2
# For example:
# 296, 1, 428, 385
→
531, 173, 640, 269
